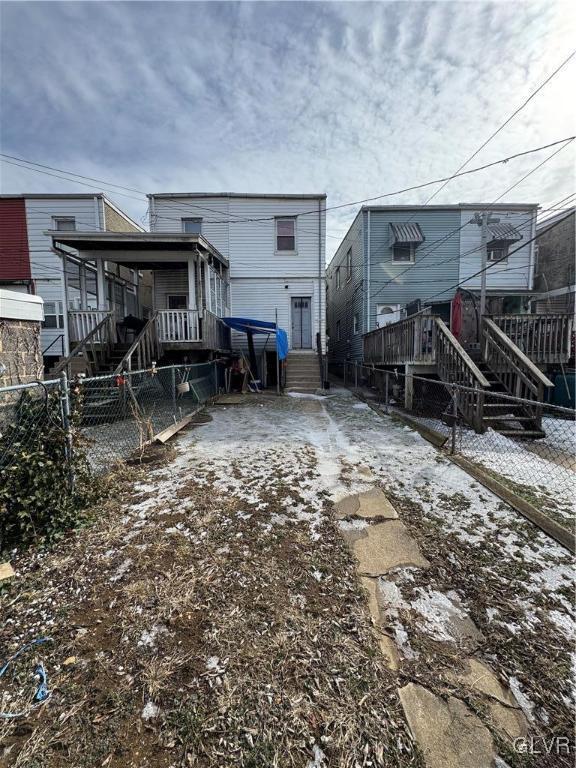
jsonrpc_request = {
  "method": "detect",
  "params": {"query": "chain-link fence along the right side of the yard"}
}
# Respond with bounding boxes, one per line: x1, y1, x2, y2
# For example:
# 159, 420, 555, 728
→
331, 362, 576, 528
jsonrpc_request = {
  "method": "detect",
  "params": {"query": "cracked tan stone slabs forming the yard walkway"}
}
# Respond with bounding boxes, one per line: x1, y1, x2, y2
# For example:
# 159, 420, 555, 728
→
335, 488, 528, 768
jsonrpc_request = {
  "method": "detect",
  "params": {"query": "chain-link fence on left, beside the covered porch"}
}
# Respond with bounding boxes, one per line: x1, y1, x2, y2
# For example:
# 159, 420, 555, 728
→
0, 363, 218, 474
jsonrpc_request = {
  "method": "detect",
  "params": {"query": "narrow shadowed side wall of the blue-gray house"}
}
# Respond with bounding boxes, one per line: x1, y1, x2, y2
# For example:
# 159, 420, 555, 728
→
326, 212, 365, 363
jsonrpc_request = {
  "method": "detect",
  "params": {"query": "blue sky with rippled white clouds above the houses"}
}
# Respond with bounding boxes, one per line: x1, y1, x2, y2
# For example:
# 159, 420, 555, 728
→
0, 0, 576, 254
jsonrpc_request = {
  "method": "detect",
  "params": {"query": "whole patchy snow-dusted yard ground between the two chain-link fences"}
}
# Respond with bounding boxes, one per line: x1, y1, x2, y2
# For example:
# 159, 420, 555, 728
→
0, 391, 574, 768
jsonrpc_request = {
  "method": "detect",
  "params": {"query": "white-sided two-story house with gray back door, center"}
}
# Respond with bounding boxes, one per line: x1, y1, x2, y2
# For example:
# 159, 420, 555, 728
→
149, 193, 326, 349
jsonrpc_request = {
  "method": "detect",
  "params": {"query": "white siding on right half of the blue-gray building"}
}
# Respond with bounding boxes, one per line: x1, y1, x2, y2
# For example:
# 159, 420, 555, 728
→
459, 209, 536, 290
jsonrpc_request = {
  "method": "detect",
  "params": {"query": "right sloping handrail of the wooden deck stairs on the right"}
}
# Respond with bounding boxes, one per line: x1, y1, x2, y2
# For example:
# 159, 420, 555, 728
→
481, 317, 554, 428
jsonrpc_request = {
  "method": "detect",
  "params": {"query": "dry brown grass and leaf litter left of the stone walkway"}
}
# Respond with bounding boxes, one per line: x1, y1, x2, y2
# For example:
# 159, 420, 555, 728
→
0, 432, 421, 768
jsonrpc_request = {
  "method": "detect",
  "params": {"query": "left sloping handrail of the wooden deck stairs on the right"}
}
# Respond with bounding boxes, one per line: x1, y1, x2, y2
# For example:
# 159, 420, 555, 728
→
434, 317, 490, 432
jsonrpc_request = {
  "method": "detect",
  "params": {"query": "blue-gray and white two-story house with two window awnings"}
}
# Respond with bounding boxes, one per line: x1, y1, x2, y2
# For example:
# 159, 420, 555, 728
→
326, 203, 537, 363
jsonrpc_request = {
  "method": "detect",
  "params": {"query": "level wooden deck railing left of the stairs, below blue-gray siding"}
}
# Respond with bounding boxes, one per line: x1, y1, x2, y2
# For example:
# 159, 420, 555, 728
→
364, 313, 436, 365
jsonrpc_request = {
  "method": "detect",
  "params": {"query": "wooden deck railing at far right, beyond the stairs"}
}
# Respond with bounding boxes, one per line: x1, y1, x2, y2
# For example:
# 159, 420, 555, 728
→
491, 314, 573, 365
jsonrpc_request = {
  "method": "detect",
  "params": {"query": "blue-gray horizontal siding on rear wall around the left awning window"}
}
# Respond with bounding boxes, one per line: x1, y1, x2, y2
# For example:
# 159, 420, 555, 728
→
364, 210, 460, 330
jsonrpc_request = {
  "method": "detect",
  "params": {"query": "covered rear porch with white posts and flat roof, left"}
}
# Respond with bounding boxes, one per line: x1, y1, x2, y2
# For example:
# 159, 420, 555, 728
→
49, 232, 230, 373
